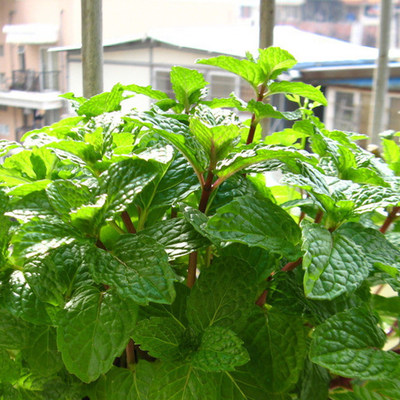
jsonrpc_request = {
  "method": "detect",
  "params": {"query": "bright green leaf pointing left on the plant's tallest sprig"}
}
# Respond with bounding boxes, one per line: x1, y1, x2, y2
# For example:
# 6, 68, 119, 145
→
197, 56, 267, 88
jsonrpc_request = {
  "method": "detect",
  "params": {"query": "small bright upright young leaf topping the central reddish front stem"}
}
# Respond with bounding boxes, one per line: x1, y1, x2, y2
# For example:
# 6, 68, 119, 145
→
190, 118, 240, 162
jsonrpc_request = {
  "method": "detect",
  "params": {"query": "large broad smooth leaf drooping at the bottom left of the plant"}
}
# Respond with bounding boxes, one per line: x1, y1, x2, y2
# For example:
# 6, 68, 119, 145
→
57, 287, 137, 383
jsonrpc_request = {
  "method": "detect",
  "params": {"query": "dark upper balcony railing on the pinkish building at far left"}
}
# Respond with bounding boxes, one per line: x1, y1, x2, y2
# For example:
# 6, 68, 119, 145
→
10, 69, 60, 92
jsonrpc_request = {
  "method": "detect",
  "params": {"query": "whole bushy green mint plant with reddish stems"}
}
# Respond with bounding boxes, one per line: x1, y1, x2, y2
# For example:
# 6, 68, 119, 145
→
0, 47, 400, 400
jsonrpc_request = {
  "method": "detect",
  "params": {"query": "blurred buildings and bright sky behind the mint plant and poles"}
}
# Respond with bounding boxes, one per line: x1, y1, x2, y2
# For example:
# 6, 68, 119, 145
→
0, 0, 400, 140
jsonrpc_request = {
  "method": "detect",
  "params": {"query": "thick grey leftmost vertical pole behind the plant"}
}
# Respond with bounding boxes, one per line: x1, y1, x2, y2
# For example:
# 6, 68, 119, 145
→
81, 0, 103, 98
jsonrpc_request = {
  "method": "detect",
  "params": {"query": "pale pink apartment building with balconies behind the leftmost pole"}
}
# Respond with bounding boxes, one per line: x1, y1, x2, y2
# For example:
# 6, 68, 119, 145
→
0, 0, 249, 140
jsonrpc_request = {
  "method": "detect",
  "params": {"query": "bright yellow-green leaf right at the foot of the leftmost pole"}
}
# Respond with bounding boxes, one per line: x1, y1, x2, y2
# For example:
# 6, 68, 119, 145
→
77, 83, 124, 117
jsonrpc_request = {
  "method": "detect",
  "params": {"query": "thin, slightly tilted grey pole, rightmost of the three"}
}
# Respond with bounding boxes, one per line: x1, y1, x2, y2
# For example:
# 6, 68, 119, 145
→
369, 0, 392, 144
